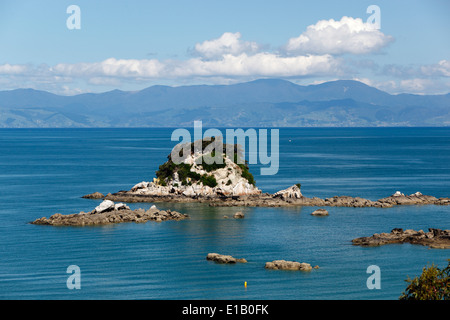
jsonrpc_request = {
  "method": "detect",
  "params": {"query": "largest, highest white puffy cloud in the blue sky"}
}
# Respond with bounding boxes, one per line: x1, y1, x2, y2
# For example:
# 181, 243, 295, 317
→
285, 17, 393, 55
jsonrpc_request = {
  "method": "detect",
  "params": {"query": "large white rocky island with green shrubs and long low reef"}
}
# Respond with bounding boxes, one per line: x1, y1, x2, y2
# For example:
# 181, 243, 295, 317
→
83, 138, 450, 208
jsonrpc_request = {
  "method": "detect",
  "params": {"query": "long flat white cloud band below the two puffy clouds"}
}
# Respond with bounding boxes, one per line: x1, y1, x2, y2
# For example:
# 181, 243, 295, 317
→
46, 53, 340, 80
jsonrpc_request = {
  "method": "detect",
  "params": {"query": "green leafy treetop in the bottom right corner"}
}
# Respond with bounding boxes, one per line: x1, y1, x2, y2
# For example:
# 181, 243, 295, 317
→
399, 259, 450, 300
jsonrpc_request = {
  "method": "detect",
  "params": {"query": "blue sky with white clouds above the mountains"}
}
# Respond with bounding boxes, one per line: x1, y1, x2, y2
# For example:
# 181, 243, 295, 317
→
0, 0, 450, 95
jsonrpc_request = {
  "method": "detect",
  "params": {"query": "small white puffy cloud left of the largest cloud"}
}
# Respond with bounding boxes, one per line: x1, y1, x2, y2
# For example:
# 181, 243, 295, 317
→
195, 32, 260, 59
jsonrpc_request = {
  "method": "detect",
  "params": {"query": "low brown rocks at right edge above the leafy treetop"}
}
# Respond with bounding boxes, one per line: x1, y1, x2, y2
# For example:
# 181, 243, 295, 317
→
352, 228, 450, 249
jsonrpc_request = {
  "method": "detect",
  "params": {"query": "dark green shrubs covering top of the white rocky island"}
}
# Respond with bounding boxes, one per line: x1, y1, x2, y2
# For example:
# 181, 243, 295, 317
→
156, 137, 256, 188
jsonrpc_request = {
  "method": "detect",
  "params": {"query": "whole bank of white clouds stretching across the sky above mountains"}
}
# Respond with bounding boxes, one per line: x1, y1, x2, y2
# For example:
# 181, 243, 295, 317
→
0, 17, 450, 94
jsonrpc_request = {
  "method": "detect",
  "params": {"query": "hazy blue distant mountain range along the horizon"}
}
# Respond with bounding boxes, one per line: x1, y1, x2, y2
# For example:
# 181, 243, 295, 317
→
0, 79, 450, 128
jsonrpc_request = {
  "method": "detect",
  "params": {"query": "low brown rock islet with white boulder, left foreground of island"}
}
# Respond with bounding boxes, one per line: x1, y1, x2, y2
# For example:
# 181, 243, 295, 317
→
31, 200, 189, 226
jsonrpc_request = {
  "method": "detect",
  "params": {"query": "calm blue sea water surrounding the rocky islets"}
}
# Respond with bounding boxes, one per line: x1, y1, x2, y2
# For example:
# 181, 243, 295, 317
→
0, 128, 450, 300
